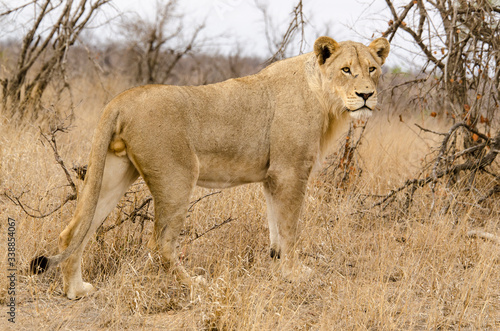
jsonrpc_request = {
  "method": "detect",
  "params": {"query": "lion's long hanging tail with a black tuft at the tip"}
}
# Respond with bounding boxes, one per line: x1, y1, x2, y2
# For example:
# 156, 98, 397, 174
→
30, 108, 118, 274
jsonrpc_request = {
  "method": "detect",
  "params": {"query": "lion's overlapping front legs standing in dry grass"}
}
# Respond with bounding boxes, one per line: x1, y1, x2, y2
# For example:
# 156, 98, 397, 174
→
264, 169, 310, 280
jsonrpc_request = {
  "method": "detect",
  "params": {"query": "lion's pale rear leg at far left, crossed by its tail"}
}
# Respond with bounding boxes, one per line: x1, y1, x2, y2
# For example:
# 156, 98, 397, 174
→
59, 152, 139, 299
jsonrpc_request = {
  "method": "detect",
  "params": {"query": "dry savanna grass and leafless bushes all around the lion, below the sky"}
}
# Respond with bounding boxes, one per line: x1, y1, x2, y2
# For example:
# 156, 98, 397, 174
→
0, 0, 500, 330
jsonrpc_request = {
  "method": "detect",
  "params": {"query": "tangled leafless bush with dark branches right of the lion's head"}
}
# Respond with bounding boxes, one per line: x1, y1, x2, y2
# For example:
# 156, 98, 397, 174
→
375, 0, 500, 213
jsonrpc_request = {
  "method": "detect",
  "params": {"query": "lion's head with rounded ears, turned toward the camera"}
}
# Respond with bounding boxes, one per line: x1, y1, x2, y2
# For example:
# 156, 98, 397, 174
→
314, 37, 390, 118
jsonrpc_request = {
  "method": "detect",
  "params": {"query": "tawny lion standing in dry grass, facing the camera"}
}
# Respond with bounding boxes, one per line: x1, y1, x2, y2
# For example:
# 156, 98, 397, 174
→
31, 37, 390, 299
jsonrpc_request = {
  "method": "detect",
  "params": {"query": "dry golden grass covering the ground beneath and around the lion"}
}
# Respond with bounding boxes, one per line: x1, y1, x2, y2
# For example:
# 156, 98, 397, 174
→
0, 74, 500, 330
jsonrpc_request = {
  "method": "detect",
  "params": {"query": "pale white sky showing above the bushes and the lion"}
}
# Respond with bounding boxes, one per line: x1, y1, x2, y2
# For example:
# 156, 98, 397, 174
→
0, 0, 415, 67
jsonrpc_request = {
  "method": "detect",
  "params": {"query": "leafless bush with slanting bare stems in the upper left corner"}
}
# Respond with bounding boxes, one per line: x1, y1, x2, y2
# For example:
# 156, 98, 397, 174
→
0, 0, 110, 119
